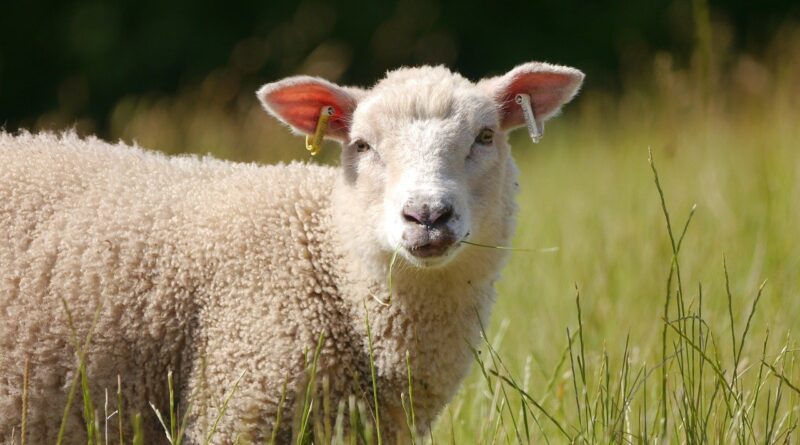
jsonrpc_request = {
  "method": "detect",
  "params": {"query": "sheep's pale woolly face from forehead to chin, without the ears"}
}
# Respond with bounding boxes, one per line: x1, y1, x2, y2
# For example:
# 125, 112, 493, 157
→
342, 67, 509, 266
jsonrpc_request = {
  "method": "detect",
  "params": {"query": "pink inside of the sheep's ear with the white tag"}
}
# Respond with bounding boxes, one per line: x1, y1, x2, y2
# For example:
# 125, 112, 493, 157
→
498, 72, 574, 128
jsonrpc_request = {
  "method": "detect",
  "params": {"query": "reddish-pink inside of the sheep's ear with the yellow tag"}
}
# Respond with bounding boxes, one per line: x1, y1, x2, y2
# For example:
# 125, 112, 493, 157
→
265, 82, 355, 137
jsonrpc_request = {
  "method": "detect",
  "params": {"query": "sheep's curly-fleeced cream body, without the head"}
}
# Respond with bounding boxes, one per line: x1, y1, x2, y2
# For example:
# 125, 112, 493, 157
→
0, 133, 511, 443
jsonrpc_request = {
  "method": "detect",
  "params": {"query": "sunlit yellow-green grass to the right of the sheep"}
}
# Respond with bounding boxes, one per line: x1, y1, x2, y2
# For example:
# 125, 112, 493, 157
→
435, 90, 800, 443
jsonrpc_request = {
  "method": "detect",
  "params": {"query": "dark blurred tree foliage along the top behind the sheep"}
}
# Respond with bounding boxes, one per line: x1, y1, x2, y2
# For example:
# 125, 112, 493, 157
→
0, 0, 800, 134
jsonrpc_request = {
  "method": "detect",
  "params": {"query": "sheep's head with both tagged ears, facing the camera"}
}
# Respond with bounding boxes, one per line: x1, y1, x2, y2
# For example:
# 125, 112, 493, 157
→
258, 62, 583, 267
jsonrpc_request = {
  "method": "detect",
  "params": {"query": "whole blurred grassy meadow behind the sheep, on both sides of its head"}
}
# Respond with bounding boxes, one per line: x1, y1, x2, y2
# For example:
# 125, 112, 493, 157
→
15, 24, 800, 444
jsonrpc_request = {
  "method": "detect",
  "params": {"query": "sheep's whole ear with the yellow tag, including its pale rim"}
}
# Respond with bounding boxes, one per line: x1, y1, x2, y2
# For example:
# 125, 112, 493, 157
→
256, 76, 359, 142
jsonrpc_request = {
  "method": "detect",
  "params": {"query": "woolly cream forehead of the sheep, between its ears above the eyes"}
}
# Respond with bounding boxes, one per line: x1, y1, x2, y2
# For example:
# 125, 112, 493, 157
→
354, 67, 497, 136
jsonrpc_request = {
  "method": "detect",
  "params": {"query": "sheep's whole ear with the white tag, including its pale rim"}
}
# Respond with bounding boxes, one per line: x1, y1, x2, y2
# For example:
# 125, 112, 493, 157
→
478, 62, 584, 129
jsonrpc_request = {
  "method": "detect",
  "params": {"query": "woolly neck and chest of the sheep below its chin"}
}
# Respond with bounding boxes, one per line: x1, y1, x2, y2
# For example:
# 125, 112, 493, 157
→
331, 180, 505, 425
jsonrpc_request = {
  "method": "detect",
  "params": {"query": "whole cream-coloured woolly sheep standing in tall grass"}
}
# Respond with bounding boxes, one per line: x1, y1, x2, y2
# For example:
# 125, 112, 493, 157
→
0, 62, 583, 443
